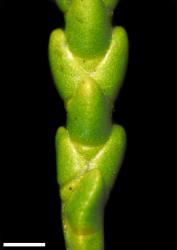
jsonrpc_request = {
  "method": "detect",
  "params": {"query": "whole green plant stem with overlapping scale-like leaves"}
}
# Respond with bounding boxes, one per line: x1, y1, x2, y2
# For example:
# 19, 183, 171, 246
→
49, 0, 128, 250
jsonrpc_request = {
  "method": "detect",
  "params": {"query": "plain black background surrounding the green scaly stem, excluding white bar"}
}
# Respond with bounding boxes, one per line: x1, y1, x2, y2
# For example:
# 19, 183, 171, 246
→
0, 0, 177, 250
